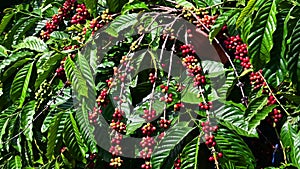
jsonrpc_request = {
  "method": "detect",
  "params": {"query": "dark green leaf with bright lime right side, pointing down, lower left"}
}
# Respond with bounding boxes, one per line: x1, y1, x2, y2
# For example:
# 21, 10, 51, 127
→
63, 113, 87, 162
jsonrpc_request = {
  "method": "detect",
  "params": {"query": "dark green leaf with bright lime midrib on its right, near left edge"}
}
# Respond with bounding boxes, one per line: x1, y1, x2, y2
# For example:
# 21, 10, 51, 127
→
10, 63, 33, 108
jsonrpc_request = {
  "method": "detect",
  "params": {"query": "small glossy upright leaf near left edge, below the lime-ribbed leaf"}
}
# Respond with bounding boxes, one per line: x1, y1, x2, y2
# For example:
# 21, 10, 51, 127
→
21, 100, 35, 141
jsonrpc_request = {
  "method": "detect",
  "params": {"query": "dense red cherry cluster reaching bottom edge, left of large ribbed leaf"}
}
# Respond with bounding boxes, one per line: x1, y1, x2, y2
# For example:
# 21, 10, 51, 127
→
140, 123, 156, 169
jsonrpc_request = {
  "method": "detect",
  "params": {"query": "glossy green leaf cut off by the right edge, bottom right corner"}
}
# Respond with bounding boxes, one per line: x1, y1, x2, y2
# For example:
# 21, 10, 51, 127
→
280, 121, 300, 168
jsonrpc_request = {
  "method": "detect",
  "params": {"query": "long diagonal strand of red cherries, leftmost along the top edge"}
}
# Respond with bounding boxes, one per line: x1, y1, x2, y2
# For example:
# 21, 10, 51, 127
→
40, 0, 76, 40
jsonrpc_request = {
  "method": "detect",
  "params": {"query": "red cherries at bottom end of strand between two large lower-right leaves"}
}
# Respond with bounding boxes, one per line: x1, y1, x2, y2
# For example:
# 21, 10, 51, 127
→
201, 121, 223, 161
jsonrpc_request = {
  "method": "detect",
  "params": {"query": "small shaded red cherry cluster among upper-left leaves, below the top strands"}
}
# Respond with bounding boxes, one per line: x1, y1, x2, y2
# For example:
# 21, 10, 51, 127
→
56, 45, 79, 82
